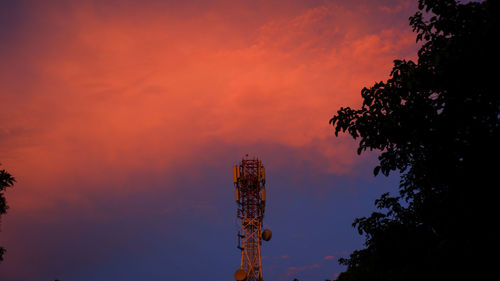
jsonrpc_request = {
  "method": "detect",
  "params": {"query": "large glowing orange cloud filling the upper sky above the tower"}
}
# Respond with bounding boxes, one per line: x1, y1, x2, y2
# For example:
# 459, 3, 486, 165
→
0, 1, 413, 210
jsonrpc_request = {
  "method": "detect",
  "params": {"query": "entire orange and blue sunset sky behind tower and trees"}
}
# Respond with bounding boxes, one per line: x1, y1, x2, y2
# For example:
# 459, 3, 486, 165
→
0, 0, 417, 281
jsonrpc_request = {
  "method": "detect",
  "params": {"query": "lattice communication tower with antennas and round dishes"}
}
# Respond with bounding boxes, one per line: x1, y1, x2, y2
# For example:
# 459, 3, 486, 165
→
233, 155, 272, 281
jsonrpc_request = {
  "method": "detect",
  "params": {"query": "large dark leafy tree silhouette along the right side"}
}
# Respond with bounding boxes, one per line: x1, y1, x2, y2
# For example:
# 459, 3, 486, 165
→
330, 0, 500, 280
